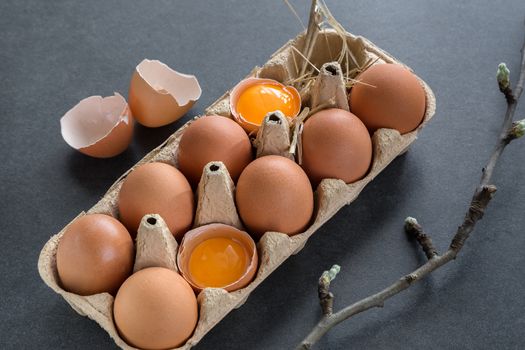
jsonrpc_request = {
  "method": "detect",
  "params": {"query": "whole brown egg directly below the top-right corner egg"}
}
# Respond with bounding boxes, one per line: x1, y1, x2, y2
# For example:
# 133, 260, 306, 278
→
301, 108, 372, 186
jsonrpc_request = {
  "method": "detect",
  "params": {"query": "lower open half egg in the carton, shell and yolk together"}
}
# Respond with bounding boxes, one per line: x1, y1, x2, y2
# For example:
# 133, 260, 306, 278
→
177, 224, 258, 292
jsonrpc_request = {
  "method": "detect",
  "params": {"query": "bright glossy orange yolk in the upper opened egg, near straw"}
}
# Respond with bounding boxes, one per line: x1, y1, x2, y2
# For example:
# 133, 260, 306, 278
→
236, 83, 299, 125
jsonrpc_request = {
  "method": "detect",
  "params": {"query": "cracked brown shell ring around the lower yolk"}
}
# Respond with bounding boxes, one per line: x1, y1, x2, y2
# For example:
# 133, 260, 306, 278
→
177, 223, 259, 293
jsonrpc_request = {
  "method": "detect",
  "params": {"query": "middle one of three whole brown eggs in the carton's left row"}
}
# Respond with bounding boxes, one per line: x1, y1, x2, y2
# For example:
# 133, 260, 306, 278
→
118, 162, 195, 241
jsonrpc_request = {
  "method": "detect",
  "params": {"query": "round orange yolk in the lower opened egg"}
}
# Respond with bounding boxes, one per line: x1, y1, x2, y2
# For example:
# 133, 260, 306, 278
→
189, 237, 249, 288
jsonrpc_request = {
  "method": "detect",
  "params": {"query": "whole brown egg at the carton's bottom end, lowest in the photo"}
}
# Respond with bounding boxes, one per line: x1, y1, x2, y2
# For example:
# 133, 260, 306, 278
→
113, 267, 198, 349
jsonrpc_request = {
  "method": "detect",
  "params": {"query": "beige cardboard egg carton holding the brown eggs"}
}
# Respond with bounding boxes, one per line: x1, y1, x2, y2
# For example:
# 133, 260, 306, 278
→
38, 29, 435, 349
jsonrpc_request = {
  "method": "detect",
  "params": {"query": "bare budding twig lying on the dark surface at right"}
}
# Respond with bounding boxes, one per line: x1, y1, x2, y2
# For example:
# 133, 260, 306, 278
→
297, 26, 525, 349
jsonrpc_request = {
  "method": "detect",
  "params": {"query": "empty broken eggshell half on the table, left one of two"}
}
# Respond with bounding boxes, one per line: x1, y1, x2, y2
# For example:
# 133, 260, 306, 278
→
60, 92, 134, 158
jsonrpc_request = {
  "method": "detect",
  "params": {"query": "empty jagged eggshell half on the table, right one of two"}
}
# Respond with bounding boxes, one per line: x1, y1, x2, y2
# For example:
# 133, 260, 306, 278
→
128, 59, 202, 128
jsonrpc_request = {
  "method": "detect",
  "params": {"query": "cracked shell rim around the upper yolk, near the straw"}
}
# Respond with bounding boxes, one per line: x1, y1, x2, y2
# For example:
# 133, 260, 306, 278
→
230, 78, 301, 134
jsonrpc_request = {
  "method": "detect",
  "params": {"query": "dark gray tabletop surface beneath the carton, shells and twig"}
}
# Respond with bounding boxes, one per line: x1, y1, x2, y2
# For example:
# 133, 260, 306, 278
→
0, 0, 525, 349
